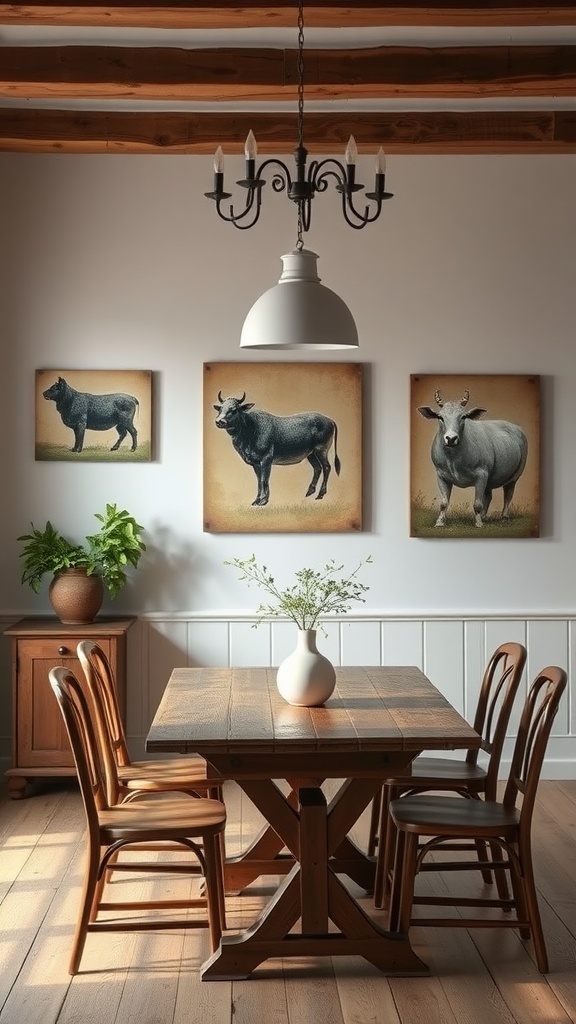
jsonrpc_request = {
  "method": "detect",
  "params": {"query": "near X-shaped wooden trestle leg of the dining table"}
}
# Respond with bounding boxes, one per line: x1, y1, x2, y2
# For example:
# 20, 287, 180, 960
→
202, 780, 428, 981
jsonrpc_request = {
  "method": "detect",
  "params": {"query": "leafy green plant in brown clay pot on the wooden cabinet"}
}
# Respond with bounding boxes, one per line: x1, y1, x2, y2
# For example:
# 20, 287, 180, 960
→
17, 505, 146, 624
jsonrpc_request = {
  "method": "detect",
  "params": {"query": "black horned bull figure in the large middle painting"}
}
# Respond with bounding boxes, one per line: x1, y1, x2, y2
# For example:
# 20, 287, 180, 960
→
213, 391, 340, 505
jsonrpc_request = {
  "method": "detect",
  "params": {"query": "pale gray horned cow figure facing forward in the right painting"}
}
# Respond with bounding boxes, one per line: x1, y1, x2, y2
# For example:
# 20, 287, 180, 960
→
418, 388, 528, 526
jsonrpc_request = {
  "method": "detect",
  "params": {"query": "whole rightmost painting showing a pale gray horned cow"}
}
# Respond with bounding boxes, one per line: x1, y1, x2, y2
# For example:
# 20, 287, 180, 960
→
410, 374, 540, 539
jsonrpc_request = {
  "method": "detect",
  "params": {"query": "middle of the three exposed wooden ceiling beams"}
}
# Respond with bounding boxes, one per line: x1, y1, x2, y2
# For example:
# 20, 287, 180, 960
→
0, 46, 576, 101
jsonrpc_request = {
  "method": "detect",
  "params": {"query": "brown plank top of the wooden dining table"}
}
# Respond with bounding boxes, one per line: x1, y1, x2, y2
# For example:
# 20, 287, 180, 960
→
147, 666, 481, 760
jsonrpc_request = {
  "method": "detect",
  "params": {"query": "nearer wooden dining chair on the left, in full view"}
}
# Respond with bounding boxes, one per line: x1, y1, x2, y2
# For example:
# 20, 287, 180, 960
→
48, 666, 225, 975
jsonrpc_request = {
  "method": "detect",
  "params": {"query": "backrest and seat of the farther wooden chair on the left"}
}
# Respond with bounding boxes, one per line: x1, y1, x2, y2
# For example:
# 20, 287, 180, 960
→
77, 640, 222, 803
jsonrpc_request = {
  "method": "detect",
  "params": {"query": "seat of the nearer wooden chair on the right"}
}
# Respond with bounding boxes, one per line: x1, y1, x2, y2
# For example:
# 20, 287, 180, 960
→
390, 795, 520, 839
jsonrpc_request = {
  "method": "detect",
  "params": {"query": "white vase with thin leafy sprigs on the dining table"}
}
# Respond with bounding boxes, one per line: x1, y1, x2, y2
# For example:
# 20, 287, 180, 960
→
224, 555, 372, 708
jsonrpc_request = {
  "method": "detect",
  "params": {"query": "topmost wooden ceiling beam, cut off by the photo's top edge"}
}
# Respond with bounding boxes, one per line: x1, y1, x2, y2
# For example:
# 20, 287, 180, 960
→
0, 0, 576, 29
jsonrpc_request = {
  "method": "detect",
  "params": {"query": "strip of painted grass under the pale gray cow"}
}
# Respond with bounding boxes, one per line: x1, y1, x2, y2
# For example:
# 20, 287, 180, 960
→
410, 495, 539, 538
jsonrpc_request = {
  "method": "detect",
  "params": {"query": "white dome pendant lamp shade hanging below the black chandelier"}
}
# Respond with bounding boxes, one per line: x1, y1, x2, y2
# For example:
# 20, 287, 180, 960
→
240, 249, 358, 349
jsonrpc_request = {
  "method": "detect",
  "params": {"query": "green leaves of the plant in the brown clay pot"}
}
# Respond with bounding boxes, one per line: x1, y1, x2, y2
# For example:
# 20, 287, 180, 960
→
17, 505, 146, 598
